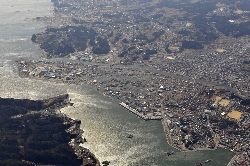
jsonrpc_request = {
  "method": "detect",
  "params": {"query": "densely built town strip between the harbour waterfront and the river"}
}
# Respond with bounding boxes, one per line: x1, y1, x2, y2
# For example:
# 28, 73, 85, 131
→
17, 59, 250, 165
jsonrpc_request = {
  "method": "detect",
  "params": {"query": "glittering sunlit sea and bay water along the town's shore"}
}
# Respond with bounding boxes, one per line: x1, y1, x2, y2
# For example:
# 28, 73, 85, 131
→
0, 0, 234, 166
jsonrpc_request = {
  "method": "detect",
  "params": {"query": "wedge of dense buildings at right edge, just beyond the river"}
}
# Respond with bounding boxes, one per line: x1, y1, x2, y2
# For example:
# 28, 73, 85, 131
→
154, 37, 250, 97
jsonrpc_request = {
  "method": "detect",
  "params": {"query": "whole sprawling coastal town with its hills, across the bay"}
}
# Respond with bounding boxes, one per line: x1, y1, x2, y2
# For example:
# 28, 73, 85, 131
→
16, 0, 250, 166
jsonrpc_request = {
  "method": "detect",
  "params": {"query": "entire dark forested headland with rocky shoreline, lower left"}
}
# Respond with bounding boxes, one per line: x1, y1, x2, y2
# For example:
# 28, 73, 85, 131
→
0, 95, 98, 166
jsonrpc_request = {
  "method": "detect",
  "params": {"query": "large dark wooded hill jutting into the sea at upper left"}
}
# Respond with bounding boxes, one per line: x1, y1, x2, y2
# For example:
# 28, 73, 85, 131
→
31, 25, 97, 56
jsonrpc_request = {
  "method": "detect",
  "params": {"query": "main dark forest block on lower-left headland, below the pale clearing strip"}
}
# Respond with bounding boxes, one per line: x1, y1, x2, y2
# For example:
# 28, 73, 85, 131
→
0, 99, 82, 166
